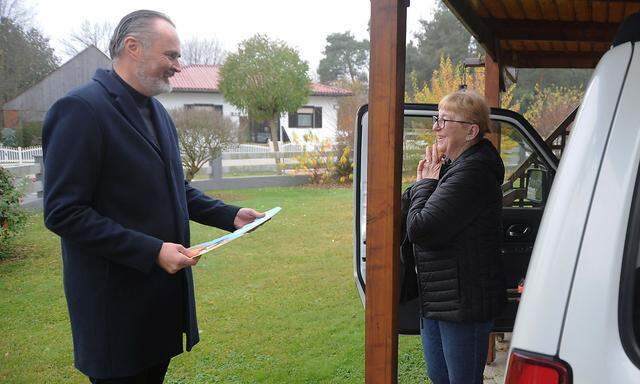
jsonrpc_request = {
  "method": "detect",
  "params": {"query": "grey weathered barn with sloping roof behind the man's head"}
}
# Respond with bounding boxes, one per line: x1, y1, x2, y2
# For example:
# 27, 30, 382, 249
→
2, 46, 111, 128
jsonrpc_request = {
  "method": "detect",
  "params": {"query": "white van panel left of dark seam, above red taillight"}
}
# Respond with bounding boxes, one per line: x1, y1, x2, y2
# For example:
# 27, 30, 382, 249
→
511, 44, 632, 357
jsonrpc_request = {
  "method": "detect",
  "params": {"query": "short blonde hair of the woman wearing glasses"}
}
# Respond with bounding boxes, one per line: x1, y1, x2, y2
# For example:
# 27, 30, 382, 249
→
438, 89, 491, 138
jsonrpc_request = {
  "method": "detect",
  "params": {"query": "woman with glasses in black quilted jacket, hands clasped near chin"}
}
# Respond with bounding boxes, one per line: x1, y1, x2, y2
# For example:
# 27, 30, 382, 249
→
403, 90, 506, 384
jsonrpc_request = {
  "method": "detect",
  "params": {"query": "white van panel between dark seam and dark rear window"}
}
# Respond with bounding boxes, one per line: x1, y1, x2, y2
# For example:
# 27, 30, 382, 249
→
559, 43, 640, 383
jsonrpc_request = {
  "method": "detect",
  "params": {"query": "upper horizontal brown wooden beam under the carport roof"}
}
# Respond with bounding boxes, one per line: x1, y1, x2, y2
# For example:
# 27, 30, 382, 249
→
482, 18, 620, 43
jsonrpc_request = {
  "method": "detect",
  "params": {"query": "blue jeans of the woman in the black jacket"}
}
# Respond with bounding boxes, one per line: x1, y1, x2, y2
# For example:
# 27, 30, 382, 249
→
420, 318, 493, 384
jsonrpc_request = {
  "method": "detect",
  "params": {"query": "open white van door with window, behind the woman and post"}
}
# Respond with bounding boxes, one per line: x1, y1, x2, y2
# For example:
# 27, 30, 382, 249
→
354, 104, 558, 334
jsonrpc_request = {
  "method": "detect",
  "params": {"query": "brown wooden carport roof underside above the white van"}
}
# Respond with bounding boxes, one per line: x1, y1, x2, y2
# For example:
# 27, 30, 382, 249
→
444, 0, 640, 68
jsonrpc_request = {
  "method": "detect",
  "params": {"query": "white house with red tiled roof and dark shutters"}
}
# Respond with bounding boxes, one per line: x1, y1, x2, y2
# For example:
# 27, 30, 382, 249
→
157, 65, 351, 143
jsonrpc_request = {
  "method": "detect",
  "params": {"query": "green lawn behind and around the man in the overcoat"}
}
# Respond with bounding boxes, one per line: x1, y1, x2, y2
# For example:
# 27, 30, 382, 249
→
0, 187, 425, 384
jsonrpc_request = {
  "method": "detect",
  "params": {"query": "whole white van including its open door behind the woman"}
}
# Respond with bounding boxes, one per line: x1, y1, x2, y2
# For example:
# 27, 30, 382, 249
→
354, 10, 640, 384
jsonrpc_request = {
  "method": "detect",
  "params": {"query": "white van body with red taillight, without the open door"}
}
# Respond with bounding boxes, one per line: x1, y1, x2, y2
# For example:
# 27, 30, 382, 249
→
506, 14, 640, 383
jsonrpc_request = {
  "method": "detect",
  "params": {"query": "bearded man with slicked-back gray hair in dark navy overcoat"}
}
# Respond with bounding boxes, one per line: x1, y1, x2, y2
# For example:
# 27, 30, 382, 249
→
42, 10, 263, 383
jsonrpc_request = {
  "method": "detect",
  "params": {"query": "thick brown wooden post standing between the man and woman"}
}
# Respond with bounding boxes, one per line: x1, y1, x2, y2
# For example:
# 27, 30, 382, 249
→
365, 0, 407, 384
